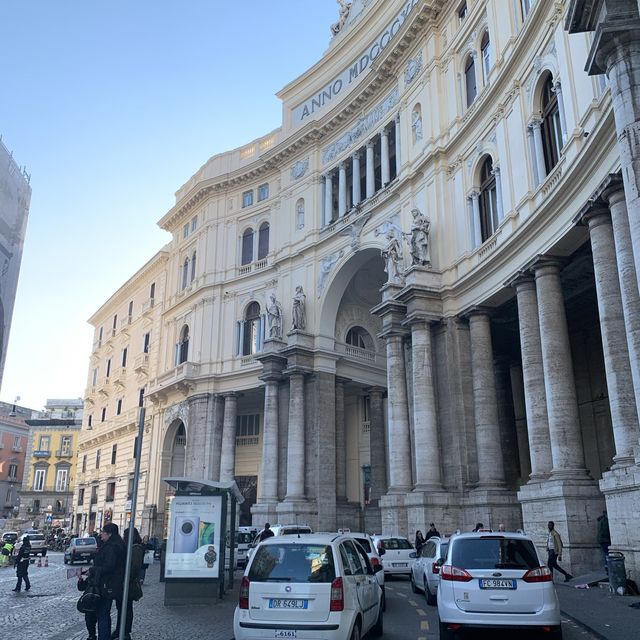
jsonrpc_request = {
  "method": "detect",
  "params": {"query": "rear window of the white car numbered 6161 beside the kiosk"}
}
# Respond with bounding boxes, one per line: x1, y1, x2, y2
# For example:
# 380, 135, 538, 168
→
248, 544, 336, 582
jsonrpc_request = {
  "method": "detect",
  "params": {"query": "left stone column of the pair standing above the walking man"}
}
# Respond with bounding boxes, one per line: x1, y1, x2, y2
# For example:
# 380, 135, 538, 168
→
512, 275, 551, 482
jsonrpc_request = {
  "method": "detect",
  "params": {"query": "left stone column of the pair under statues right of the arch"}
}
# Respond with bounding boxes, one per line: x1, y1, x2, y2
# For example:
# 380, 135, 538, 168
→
385, 334, 411, 493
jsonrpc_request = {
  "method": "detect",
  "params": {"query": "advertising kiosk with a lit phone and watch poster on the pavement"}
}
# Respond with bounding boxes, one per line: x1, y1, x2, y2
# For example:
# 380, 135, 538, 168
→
164, 478, 244, 605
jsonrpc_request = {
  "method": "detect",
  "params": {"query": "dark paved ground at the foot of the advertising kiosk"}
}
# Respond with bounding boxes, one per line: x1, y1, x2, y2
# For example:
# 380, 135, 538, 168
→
69, 562, 241, 640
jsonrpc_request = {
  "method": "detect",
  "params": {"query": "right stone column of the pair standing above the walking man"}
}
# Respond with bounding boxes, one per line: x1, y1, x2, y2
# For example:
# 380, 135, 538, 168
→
532, 258, 586, 478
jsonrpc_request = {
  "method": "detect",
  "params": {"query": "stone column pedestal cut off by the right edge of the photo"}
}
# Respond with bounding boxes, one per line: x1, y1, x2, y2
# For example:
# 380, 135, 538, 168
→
597, 460, 640, 582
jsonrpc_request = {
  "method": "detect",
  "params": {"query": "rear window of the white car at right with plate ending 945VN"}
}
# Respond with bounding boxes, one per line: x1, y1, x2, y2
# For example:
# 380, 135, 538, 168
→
451, 537, 540, 570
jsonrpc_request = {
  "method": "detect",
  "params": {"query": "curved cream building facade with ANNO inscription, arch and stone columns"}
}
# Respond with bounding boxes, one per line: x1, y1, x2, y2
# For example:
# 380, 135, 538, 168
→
76, 0, 640, 573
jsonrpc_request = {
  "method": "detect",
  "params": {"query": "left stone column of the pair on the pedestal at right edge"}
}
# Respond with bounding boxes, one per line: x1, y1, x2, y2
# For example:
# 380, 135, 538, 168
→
583, 208, 639, 465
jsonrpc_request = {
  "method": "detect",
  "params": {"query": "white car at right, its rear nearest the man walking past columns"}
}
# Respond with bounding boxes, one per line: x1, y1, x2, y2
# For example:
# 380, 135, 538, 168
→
438, 532, 562, 640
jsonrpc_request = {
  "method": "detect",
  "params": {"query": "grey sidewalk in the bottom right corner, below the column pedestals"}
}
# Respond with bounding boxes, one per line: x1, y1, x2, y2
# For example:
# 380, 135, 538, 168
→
556, 579, 640, 640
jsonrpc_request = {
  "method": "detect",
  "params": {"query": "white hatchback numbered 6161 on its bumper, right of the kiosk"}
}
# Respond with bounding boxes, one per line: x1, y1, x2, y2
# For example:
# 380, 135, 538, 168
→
233, 533, 383, 640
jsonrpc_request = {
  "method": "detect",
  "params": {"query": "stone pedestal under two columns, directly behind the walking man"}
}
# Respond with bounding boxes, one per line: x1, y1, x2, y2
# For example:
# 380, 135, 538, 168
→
518, 473, 604, 576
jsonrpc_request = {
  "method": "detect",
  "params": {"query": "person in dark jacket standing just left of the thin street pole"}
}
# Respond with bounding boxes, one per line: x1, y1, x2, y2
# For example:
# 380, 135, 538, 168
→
90, 522, 126, 640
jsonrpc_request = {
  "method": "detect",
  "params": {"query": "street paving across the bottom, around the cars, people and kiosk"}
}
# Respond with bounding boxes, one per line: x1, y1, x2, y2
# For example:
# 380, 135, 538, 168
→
0, 553, 595, 640
